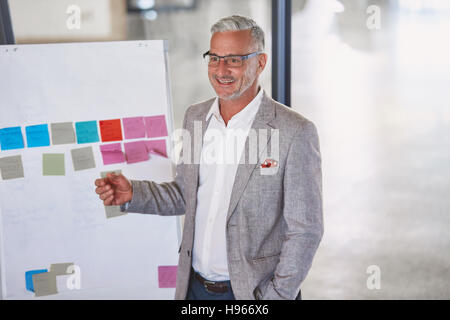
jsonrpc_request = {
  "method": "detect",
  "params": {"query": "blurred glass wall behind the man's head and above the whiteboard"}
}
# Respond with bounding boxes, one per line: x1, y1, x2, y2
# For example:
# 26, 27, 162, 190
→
9, 0, 271, 128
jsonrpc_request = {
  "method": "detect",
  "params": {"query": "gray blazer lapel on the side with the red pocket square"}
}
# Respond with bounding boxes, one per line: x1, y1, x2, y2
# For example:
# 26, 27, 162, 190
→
227, 93, 275, 222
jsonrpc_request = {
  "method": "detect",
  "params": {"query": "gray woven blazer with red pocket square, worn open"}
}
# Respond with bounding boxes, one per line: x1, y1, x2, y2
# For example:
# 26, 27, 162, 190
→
128, 94, 323, 300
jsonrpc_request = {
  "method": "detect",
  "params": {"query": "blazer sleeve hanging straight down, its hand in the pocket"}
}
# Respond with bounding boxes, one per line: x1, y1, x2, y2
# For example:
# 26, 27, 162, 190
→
262, 121, 323, 300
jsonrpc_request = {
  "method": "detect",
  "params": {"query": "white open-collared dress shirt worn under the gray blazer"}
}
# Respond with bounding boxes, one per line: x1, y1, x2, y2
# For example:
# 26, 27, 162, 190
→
192, 89, 263, 281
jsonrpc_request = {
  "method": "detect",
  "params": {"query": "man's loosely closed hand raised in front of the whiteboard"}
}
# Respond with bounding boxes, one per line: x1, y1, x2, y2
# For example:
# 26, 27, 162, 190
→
95, 173, 133, 206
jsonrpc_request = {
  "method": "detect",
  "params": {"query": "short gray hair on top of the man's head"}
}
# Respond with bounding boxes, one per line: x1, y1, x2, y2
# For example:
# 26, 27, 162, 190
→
211, 15, 264, 51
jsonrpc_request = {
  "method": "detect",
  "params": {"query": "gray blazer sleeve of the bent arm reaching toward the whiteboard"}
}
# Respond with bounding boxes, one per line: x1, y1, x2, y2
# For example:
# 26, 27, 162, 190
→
126, 112, 188, 216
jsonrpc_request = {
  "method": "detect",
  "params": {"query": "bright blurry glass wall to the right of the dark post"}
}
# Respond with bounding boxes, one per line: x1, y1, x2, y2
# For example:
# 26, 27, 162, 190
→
292, 0, 450, 299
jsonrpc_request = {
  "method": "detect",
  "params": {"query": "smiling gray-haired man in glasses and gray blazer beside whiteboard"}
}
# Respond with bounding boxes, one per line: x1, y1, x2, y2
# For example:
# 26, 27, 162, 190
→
95, 16, 323, 299
